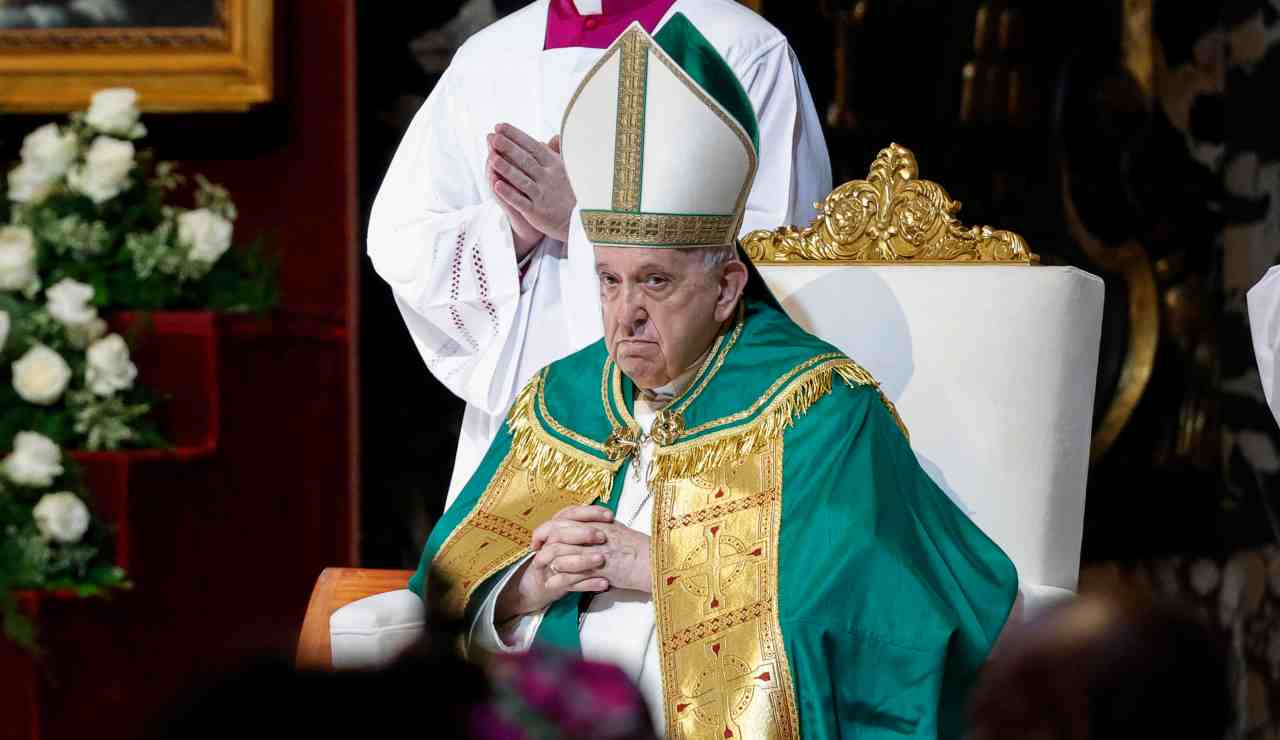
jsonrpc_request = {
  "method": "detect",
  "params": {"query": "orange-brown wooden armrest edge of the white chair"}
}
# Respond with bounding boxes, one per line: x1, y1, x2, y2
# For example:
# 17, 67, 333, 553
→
294, 568, 413, 671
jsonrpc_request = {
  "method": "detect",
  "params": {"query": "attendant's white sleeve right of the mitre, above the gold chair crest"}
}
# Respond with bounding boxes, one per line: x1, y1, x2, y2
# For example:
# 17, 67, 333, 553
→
735, 38, 831, 234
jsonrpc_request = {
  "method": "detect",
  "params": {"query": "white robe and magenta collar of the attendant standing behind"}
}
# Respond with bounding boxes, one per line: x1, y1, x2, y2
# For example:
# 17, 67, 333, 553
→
369, 0, 831, 504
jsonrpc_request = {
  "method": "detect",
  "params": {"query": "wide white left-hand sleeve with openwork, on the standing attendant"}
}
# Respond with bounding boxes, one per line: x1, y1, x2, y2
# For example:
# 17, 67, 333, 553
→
369, 64, 541, 415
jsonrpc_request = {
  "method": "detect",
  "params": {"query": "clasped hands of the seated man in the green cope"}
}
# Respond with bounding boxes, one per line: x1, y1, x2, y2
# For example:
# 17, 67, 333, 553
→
494, 506, 652, 622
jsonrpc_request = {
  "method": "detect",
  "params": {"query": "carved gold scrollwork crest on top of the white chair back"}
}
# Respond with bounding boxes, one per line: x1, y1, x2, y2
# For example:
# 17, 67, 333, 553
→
742, 143, 1039, 265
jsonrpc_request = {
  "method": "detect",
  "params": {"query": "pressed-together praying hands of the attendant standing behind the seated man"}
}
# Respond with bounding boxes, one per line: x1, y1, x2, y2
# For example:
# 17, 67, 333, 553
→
485, 123, 577, 242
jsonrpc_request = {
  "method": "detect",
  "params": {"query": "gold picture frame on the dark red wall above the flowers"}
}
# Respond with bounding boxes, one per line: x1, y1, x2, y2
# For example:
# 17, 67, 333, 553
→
0, 0, 274, 113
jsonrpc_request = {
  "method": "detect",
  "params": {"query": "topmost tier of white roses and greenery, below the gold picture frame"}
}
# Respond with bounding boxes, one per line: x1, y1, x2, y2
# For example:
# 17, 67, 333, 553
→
0, 87, 275, 311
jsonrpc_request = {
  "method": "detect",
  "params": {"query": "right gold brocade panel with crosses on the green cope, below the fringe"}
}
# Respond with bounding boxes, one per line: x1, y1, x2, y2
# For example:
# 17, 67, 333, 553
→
652, 439, 800, 740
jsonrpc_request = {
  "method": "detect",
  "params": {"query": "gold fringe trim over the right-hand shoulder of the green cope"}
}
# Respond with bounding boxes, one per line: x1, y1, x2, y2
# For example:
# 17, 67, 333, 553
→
649, 358, 910, 487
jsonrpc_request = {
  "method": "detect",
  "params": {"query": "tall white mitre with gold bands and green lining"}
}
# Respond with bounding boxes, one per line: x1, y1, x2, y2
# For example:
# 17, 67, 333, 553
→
561, 13, 759, 248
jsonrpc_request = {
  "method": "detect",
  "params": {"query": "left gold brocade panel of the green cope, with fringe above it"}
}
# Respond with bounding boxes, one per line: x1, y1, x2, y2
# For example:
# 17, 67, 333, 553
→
431, 370, 620, 615
